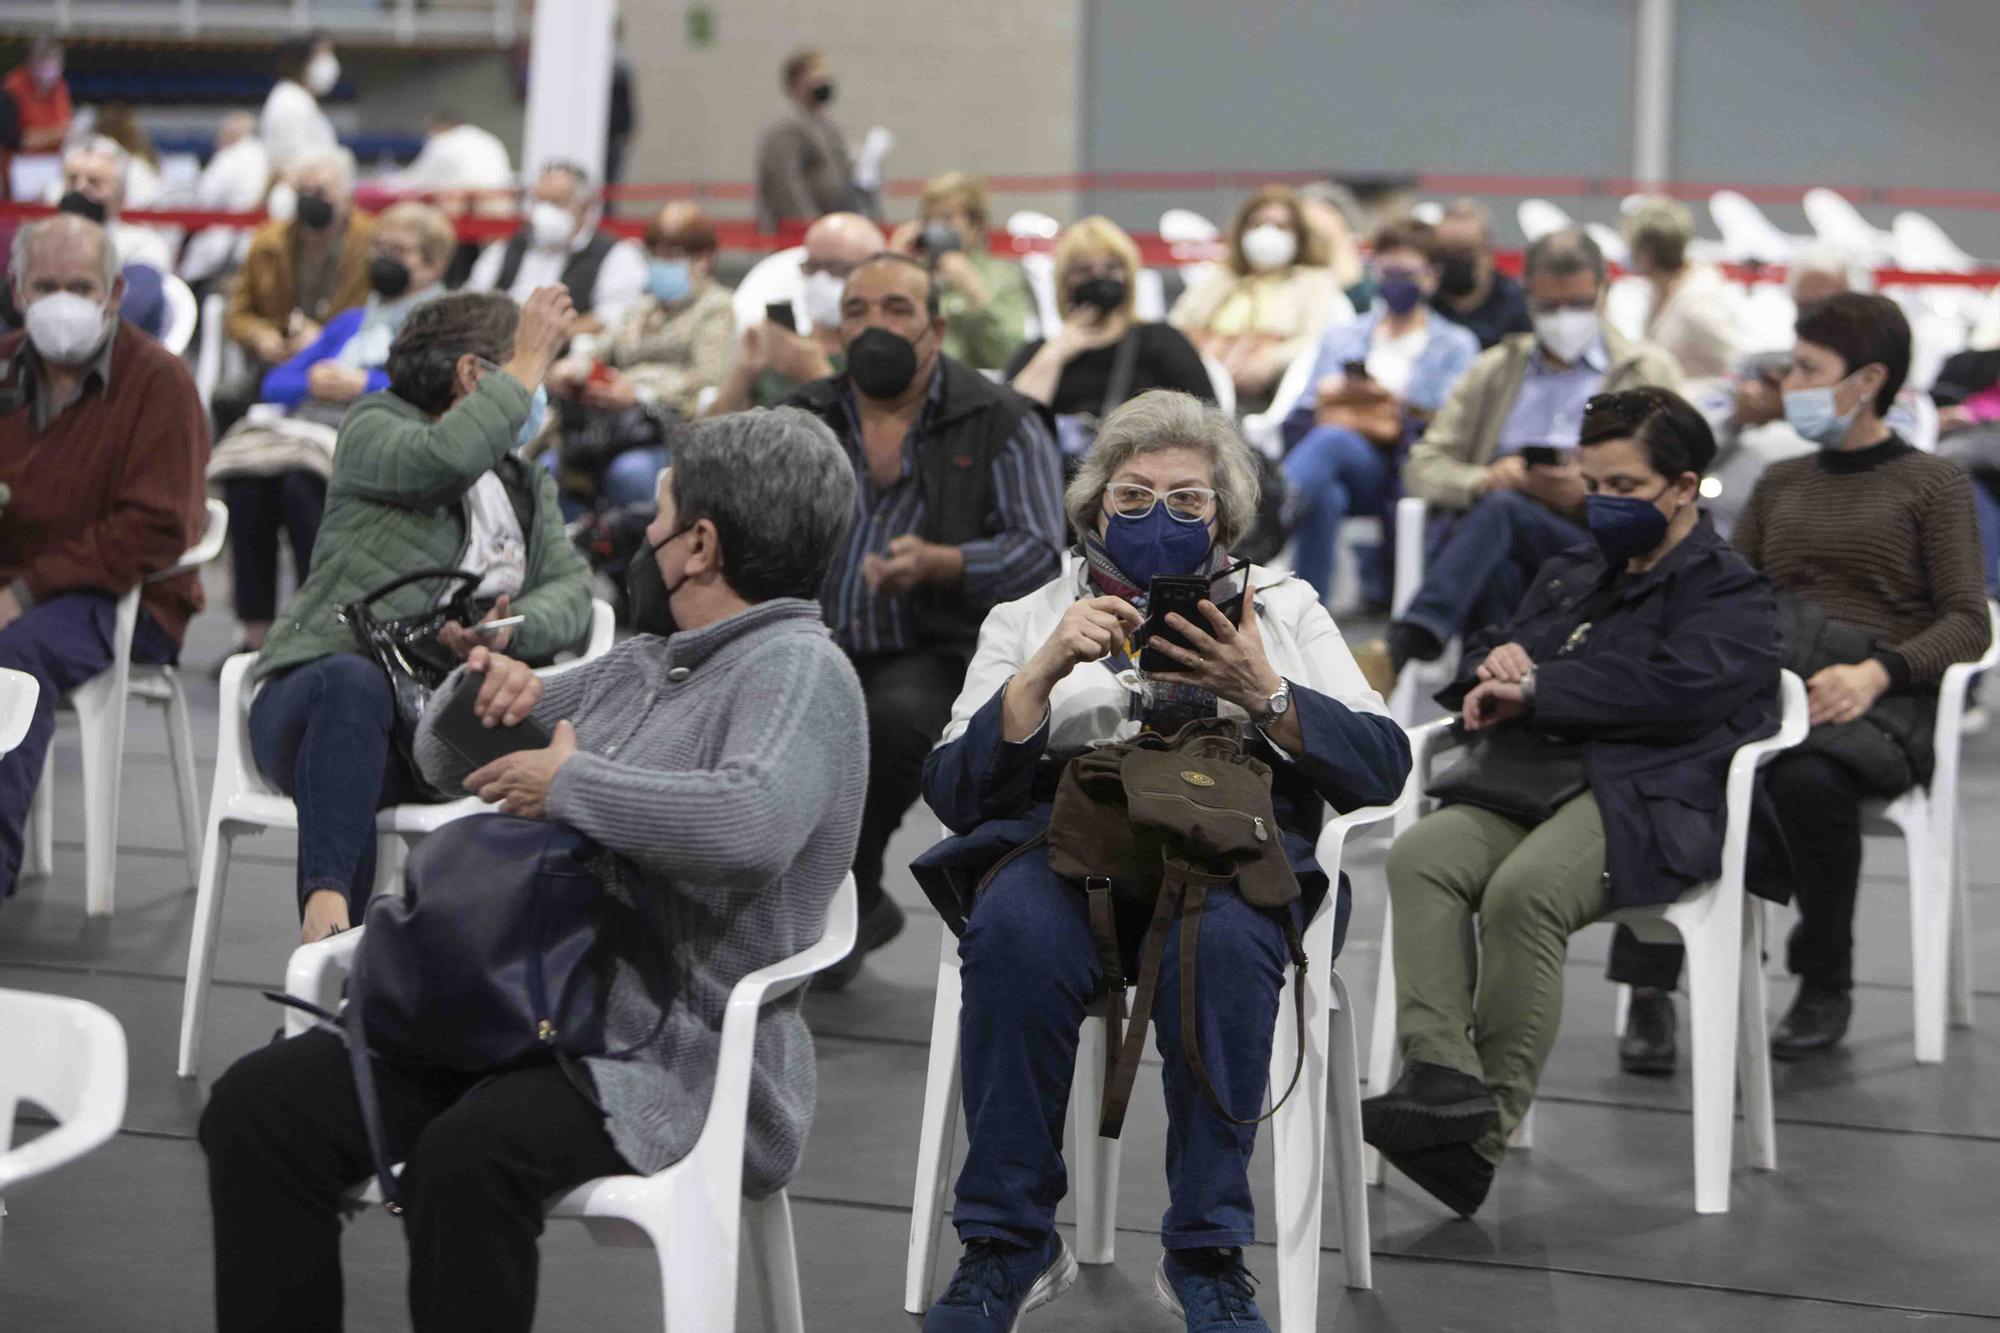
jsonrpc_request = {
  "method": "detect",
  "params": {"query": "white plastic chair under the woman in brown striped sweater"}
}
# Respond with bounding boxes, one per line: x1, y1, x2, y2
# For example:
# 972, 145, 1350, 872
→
1862, 602, 2000, 1065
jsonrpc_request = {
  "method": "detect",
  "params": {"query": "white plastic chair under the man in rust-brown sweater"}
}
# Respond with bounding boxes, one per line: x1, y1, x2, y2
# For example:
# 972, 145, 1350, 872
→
22, 500, 230, 917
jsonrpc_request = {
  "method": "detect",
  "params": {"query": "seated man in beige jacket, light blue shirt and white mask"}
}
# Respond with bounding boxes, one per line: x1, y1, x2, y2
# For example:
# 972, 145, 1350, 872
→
1362, 230, 1680, 685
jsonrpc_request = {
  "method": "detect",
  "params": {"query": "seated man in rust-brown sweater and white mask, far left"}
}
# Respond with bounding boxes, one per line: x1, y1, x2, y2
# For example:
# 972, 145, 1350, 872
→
0, 216, 208, 899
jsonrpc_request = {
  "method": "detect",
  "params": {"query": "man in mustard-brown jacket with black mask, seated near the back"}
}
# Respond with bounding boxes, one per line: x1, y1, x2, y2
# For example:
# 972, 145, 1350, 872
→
212, 148, 374, 432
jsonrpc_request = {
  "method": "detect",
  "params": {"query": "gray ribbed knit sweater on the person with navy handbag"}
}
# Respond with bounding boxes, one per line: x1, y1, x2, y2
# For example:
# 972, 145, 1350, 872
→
416, 598, 868, 1197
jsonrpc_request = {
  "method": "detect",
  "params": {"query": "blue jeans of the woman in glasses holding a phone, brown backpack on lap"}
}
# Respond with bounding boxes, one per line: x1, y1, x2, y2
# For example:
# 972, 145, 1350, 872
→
952, 849, 1318, 1249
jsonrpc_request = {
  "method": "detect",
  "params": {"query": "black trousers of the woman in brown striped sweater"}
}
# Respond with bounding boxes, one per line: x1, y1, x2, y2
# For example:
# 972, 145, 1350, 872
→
1610, 751, 1870, 991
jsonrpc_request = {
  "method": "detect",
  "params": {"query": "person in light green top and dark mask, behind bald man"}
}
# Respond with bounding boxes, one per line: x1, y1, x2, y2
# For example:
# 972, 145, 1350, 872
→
888, 172, 1034, 370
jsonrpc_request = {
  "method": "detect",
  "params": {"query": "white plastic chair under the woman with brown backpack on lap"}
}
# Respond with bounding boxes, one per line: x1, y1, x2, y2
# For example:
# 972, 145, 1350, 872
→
902, 801, 1400, 1333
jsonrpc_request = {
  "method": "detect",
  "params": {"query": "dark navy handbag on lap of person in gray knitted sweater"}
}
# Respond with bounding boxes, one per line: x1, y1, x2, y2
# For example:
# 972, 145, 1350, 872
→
266, 815, 666, 1213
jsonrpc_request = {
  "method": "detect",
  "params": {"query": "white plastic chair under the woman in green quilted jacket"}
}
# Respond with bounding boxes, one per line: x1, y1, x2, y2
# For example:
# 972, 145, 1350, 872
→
176, 600, 614, 1079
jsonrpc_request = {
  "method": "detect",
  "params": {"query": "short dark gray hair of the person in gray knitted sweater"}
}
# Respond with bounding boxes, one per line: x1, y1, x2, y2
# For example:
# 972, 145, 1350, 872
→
670, 408, 858, 602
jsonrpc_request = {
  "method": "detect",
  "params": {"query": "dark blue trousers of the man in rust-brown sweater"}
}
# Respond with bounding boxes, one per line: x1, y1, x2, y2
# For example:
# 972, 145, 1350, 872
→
0, 592, 180, 899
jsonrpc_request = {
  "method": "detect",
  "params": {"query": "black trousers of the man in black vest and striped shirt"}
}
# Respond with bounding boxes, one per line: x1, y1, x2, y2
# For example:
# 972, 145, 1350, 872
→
854, 648, 968, 915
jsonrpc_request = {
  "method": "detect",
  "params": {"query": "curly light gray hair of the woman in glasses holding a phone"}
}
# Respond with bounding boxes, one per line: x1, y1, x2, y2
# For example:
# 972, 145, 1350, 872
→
1062, 388, 1258, 550
